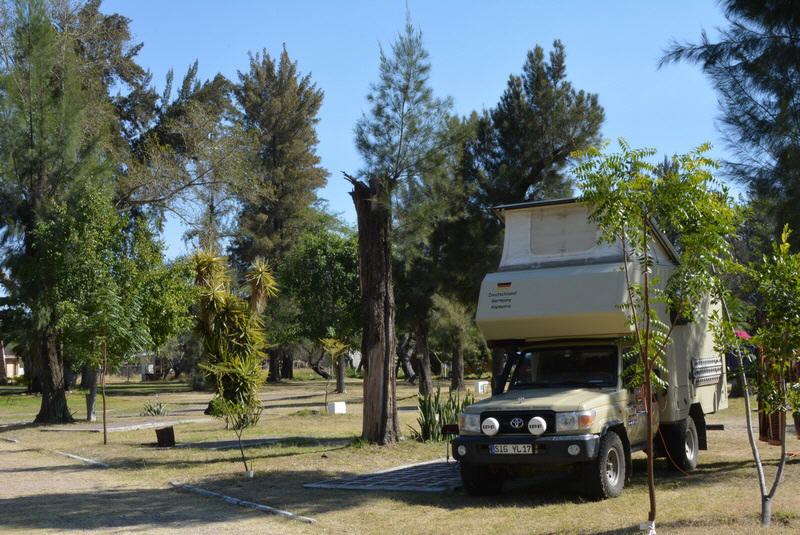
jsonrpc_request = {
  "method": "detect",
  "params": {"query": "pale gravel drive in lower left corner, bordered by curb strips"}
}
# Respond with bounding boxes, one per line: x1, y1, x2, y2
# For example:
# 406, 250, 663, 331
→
0, 442, 316, 534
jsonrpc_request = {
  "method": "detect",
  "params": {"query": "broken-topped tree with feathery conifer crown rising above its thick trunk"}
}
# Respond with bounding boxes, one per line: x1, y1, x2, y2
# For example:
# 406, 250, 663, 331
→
345, 19, 450, 444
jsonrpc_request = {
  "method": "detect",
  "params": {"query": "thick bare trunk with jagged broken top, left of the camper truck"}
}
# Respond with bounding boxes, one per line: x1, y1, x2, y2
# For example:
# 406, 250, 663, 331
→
351, 178, 400, 445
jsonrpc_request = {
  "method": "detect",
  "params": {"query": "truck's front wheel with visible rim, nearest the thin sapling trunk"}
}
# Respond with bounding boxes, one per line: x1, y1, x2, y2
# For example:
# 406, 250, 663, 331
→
582, 431, 628, 500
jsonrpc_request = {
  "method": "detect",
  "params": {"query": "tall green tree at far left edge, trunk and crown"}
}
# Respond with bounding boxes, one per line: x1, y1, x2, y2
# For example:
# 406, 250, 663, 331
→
0, 0, 115, 423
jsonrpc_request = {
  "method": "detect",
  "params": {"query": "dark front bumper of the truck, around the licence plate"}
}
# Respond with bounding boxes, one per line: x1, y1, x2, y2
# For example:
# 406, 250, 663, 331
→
452, 435, 600, 465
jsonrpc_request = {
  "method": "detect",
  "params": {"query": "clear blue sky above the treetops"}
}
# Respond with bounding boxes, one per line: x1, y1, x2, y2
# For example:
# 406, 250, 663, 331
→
102, 0, 726, 256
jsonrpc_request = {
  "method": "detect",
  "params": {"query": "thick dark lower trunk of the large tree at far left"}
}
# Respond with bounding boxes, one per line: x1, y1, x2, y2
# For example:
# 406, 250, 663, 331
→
34, 329, 73, 424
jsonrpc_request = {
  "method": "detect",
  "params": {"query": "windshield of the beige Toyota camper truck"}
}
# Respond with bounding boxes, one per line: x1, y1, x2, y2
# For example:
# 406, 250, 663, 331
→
511, 346, 618, 388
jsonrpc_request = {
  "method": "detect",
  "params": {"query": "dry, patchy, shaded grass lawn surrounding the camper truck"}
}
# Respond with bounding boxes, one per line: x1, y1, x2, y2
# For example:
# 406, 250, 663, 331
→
0, 377, 800, 534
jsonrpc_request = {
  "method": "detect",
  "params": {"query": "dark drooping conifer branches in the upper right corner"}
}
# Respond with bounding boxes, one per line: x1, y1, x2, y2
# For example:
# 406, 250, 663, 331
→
661, 0, 800, 252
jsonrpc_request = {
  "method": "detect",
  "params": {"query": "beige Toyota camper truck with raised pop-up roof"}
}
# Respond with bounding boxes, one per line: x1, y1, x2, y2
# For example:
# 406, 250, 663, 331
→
452, 199, 728, 499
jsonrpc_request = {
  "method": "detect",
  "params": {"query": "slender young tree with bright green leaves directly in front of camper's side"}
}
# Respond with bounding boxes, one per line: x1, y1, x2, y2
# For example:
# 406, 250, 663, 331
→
576, 140, 736, 533
